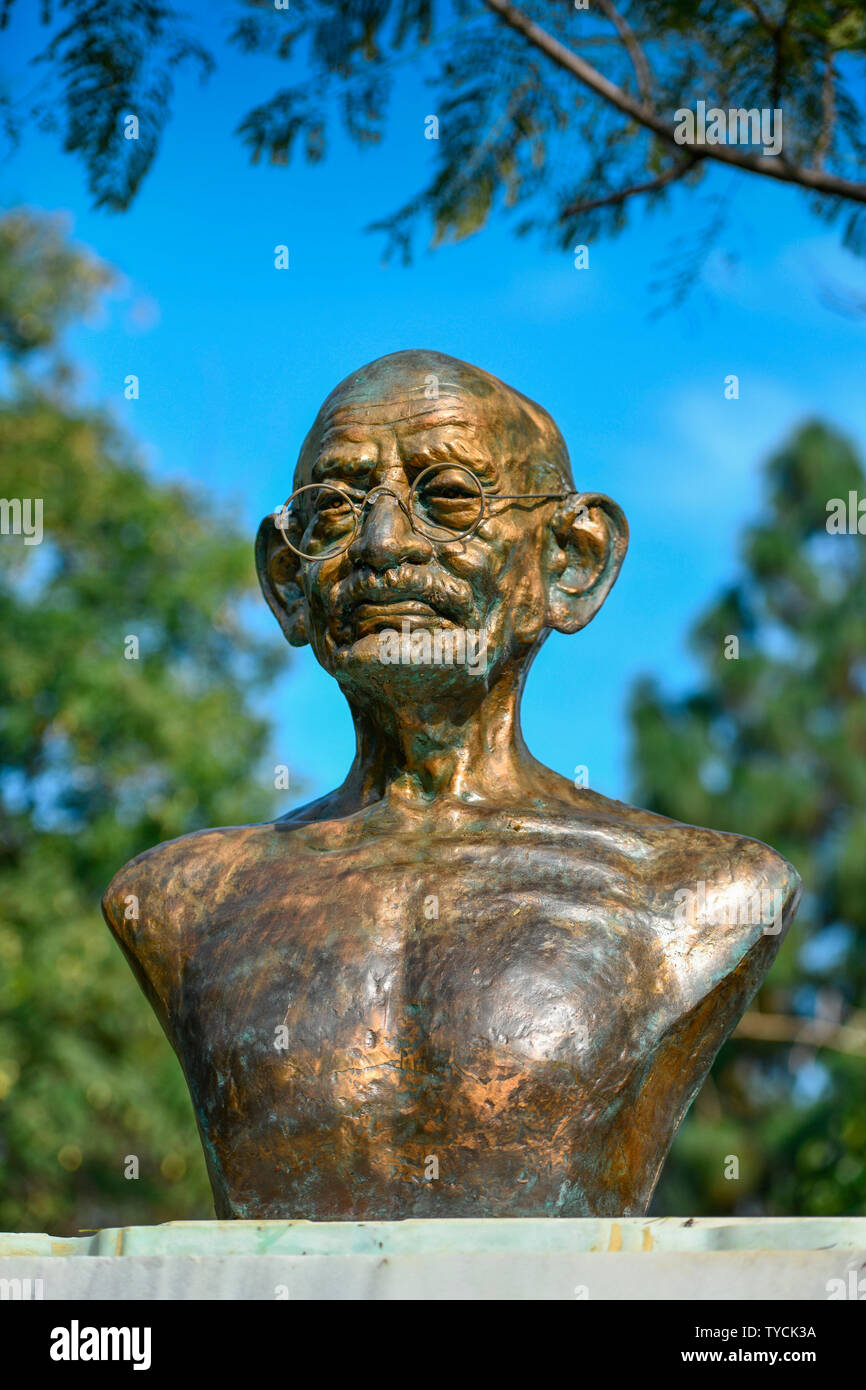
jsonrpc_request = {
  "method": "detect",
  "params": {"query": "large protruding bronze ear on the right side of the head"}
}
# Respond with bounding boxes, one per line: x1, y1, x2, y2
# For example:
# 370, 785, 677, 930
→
548, 492, 628, 632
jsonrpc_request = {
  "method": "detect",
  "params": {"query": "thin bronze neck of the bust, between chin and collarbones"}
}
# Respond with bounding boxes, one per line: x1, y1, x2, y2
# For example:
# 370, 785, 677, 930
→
342, 669, 534, 806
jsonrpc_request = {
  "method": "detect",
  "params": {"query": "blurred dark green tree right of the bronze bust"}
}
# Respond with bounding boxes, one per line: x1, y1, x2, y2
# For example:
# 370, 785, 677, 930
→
631, 423, 866, 1215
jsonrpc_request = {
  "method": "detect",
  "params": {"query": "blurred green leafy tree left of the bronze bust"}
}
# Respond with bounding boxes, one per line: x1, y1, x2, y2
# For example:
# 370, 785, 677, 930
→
0, 205, 282, 1233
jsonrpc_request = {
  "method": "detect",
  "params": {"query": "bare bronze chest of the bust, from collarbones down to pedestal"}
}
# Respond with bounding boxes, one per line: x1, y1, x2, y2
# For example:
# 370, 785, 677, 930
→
167, 844, 677, 1215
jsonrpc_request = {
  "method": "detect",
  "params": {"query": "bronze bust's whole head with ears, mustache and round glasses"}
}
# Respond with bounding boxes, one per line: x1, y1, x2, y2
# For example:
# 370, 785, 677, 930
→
256, 349, 628, 672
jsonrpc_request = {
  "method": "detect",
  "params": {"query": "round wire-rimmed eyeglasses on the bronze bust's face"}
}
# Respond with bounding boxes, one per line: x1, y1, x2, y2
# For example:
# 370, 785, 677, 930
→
274, 463, 577, 560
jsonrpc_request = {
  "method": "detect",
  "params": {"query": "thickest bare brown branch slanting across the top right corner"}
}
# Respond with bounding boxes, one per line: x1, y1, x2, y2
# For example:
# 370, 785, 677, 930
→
484, 0, 866, 203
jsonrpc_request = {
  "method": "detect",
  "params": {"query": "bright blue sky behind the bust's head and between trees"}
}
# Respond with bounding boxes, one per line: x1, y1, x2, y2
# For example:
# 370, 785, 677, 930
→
0, 0, 866, 806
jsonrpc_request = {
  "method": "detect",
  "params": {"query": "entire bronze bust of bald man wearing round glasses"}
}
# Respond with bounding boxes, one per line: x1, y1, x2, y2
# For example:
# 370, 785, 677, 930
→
103, 350, 799, 1220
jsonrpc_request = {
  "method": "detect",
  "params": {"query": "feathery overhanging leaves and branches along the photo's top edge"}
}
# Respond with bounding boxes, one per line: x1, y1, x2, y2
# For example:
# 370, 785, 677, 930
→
0, 0, 866, 278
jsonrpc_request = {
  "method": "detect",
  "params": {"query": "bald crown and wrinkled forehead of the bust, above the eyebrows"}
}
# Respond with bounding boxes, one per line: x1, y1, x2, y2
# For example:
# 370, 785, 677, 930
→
295, 348, 574, 491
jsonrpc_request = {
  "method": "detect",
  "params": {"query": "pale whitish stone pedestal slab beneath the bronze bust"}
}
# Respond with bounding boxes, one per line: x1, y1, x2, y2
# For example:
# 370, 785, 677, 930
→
0, 1216, 866, 1301
